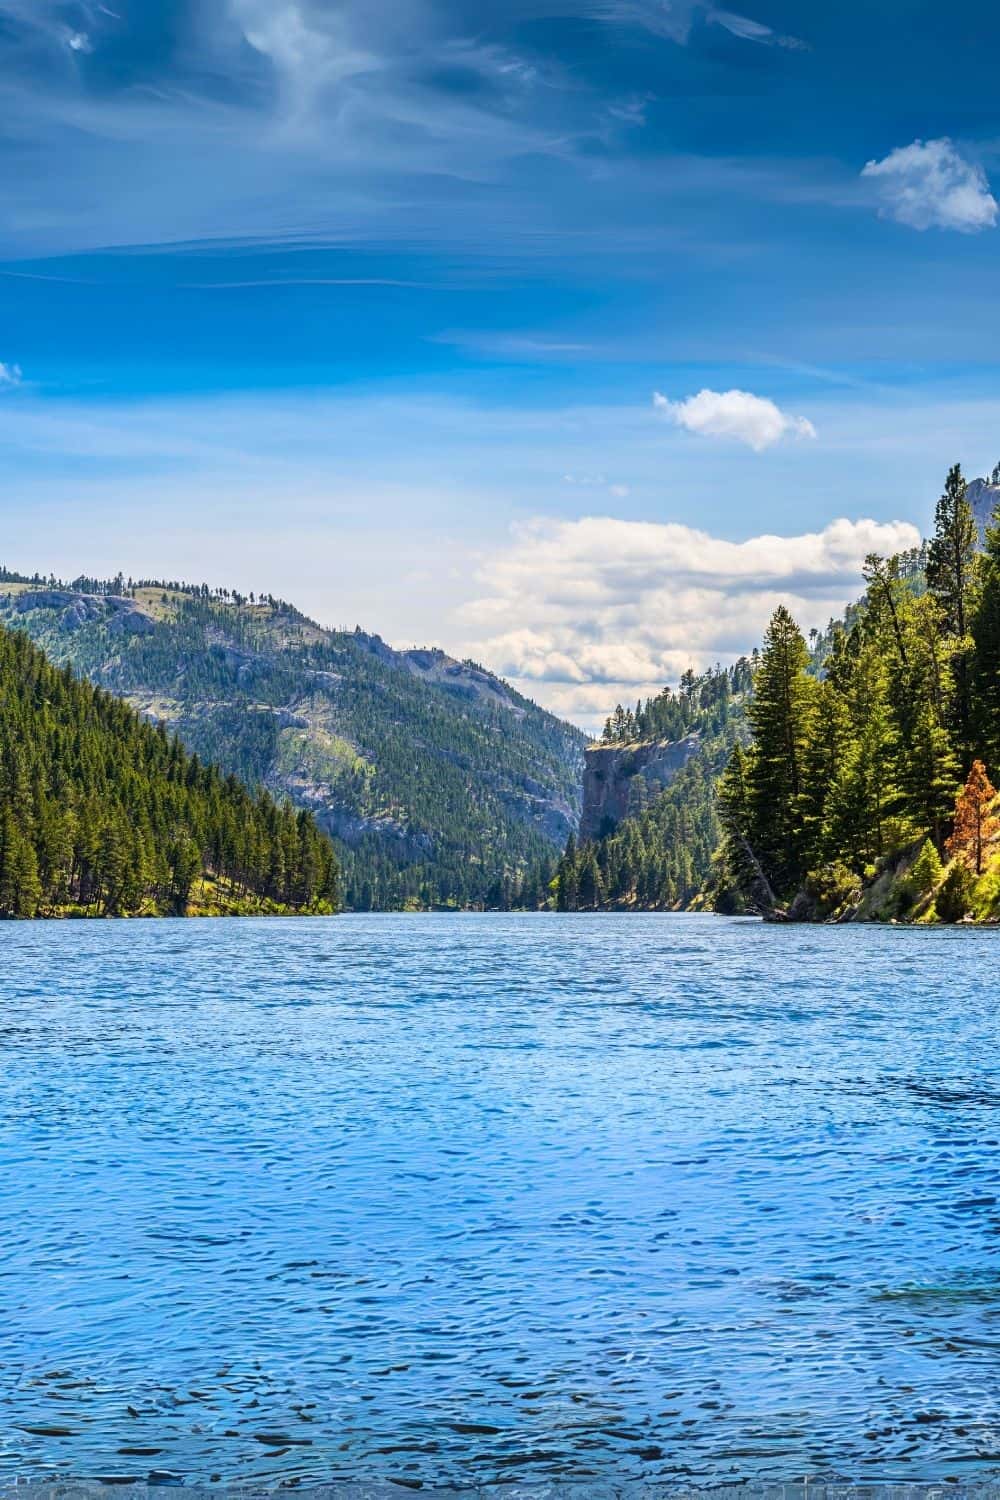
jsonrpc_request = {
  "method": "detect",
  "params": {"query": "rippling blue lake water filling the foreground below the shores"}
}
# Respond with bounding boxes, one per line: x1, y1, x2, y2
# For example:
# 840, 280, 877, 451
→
0, 915, 1000, 1484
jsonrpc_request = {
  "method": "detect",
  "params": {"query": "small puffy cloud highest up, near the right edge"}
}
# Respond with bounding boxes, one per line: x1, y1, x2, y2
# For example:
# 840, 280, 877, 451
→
861, 137, 997, 234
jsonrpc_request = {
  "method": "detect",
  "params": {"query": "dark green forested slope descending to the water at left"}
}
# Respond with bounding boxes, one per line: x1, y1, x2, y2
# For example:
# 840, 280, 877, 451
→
0, 629, 339, 917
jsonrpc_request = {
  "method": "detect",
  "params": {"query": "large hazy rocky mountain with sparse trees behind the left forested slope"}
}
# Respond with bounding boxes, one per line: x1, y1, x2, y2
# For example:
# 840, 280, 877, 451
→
0, 572, 586, 909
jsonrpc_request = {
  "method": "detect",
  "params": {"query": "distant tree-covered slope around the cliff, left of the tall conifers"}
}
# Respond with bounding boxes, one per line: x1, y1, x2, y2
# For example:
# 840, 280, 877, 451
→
553, 659, 754, 911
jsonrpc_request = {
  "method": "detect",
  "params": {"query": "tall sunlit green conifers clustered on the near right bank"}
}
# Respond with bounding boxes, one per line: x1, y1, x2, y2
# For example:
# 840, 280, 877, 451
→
720, 467, 1000, 915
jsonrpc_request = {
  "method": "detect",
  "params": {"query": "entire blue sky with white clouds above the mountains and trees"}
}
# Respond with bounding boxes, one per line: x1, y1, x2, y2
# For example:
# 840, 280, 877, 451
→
0, 0, 1000, 723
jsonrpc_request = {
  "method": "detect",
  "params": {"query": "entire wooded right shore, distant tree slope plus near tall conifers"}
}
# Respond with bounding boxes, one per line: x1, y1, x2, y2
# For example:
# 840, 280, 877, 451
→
553, 467, 1000, 923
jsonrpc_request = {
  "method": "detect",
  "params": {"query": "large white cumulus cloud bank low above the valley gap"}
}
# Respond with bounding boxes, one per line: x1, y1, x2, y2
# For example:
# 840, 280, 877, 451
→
463, 516, 919, 728
